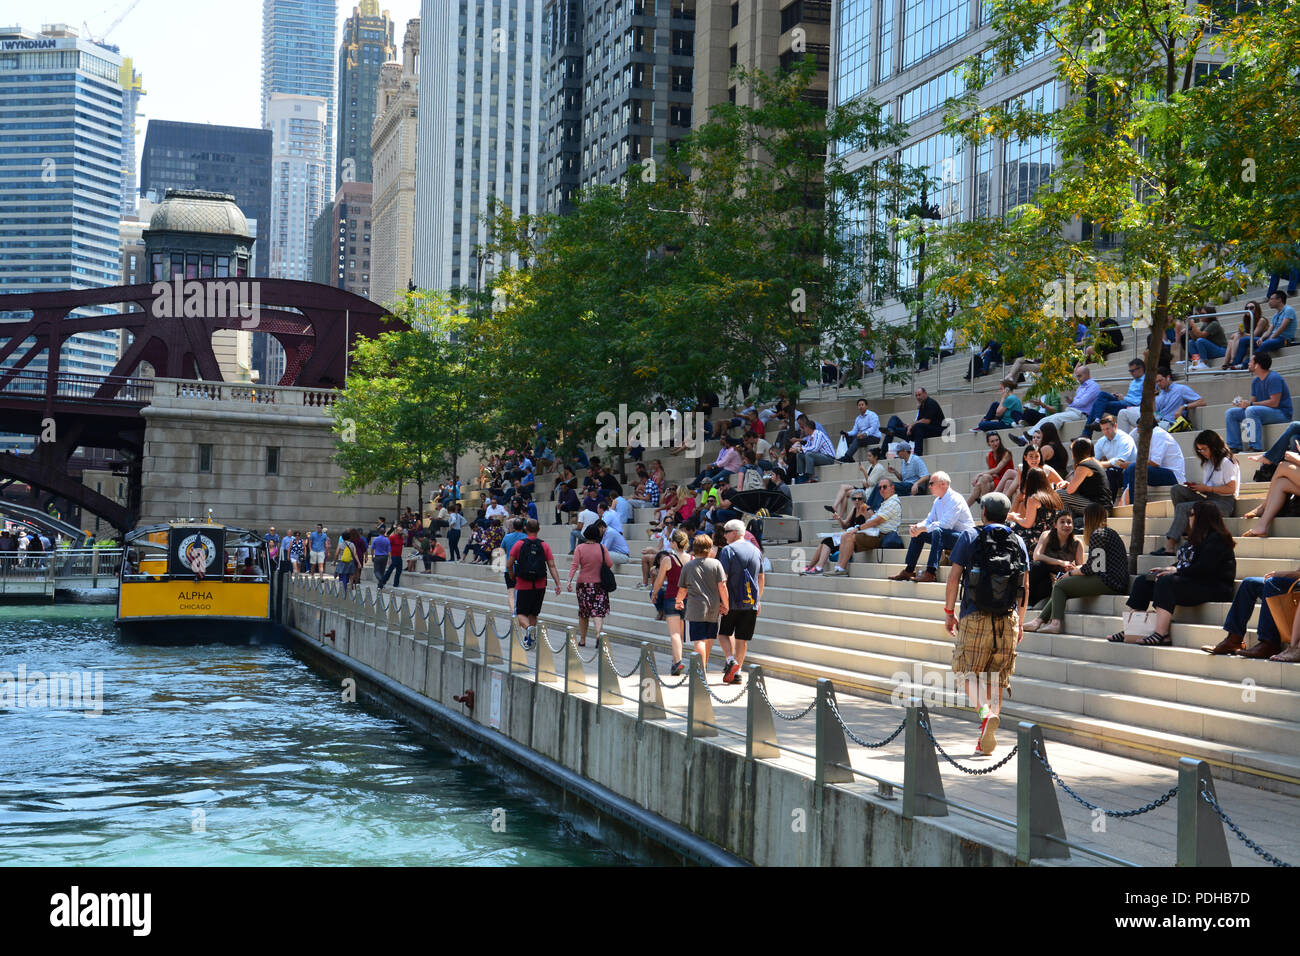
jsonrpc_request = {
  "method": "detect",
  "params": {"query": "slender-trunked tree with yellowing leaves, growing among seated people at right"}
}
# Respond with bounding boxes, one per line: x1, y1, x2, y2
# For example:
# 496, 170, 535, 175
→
931, 0, 1292, 564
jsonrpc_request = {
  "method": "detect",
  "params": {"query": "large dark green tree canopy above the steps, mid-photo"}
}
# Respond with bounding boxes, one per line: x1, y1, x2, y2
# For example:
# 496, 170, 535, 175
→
484, 61, 918, 455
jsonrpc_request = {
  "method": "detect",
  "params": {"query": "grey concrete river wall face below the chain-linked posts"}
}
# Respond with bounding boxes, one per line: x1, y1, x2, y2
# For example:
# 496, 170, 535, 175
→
286, 589, 1034, 866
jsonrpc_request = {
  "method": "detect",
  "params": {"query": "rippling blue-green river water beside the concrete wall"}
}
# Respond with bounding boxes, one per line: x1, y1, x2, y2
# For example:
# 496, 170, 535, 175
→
0, 605, 636, 866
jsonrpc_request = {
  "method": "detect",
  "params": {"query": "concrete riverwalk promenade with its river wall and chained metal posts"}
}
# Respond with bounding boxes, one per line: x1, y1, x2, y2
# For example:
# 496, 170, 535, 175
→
285, 575, 1300, 866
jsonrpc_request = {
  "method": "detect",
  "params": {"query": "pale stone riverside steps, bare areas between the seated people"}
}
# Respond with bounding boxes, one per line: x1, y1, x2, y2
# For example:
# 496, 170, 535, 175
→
418, 287, 1300, 795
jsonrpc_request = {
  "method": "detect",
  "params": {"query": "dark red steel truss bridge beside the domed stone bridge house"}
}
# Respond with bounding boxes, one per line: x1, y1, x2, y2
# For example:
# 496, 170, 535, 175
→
0, 278, 395, 531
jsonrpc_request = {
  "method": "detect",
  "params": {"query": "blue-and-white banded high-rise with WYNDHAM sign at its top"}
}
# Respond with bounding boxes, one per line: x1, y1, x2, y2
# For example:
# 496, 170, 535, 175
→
0, 23, 126, 382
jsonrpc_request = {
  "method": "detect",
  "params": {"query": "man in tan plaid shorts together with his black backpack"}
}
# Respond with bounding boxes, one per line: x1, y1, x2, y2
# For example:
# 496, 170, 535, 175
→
944, 492, 1030, 757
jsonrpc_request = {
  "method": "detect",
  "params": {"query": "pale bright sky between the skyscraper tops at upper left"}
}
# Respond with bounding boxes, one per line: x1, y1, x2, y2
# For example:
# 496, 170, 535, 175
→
27, 0, 420, 157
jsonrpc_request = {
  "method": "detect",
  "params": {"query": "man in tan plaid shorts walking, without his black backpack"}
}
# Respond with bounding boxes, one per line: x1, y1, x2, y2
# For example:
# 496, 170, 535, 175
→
944, 492, 1030, 757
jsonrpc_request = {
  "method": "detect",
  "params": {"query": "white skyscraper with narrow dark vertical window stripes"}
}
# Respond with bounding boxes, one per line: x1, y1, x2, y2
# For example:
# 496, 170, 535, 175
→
413, 0, 542, 289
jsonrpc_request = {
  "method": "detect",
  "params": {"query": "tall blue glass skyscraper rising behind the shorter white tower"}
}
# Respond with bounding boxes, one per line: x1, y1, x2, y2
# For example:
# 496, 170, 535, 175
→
261, 0, 338, 187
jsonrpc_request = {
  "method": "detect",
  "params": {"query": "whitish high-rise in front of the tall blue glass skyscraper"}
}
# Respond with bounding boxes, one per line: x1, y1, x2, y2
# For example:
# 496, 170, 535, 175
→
267, 92, 329, 281
